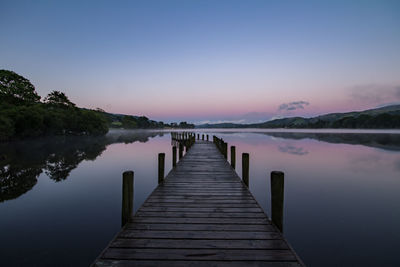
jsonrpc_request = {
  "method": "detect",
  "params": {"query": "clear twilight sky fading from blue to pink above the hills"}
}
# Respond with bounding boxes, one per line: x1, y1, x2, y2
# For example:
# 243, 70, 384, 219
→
0, 0, 400, 122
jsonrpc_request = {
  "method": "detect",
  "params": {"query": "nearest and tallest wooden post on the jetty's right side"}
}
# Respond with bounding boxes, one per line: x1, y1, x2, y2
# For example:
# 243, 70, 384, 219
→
271, 171, 284, 232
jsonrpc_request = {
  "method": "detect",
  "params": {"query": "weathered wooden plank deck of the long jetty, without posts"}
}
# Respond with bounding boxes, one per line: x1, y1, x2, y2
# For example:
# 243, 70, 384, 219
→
93, 141, 303, 267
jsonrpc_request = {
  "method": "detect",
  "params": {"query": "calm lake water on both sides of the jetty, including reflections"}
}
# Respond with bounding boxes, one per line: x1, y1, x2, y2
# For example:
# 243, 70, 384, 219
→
0, 129, 400, 266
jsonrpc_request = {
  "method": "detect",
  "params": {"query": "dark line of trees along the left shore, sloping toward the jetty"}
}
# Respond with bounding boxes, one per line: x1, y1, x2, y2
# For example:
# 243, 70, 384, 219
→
0, 70, 194, 141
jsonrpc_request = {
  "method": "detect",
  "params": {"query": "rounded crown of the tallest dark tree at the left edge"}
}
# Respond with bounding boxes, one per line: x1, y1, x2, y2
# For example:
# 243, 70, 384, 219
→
0, 70, 40, 104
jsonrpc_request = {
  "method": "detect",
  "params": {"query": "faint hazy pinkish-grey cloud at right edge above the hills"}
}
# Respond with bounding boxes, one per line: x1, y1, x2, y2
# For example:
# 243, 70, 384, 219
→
350, 84, 400, 105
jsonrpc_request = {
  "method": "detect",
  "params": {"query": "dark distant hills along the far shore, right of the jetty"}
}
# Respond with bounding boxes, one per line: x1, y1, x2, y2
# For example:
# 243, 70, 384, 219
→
196, 105, 400, 129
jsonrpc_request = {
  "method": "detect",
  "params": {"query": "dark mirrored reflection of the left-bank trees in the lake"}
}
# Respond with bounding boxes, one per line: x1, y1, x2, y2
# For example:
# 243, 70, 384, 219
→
0, 130, 163, 202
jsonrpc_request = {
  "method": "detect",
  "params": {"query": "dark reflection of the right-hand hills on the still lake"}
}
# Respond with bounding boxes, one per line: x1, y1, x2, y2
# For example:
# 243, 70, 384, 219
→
263, 132, 400, 151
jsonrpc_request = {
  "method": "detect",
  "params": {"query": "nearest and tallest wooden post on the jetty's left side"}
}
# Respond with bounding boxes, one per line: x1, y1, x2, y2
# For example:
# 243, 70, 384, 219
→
121, 171, 133, 227
